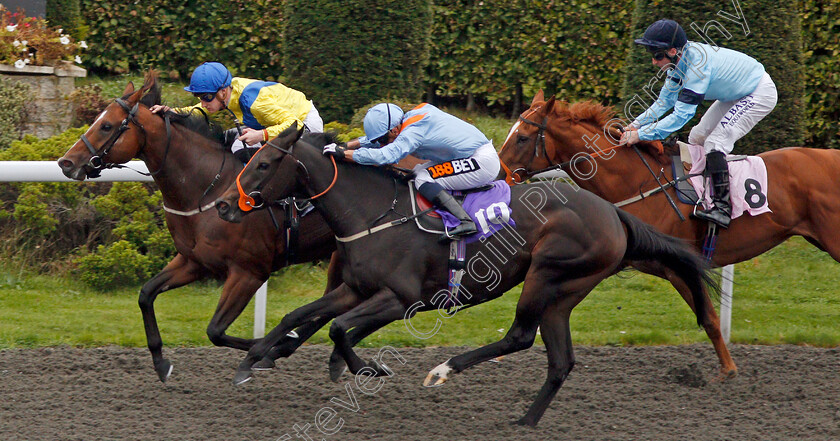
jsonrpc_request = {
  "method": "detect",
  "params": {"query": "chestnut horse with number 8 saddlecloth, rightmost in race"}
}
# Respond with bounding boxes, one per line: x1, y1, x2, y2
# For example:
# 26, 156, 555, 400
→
499, 92, 840, 375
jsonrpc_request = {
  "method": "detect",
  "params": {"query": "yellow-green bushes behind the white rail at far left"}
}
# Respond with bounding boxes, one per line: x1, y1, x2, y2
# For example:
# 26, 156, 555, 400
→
0, 126, 175, 290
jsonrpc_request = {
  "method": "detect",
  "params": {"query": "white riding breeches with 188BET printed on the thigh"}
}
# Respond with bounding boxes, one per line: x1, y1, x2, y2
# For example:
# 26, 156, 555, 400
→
414, 142, 502, 190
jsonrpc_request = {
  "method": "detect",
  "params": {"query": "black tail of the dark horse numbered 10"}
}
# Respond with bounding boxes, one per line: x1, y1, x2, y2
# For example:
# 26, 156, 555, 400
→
616, 208, 719, 326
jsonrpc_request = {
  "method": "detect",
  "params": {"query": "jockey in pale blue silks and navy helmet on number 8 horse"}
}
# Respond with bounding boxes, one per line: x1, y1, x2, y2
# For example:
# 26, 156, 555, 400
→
622, 20, 778, 228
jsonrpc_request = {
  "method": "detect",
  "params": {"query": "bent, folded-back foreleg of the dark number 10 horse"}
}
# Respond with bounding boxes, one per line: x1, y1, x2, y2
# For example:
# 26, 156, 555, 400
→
330, 288, 406, 381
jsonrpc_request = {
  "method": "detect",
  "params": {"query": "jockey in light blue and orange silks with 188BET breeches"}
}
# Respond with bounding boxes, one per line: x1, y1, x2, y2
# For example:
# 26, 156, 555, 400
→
324, 103, 501, 237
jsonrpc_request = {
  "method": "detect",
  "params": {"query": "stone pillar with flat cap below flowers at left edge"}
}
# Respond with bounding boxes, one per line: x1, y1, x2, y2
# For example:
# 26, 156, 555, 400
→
0, 63, 87, 138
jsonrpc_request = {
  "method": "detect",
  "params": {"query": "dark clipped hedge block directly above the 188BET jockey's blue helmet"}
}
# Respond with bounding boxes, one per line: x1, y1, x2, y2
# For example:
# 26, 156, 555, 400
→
283, 0, 432, 121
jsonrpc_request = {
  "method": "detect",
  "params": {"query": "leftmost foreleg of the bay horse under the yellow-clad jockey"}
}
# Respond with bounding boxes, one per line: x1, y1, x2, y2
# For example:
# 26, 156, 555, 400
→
137, 254, 203, 382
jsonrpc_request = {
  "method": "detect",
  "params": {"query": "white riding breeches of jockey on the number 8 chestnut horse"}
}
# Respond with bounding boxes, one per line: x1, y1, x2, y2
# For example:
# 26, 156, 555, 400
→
688, 72, 779, 154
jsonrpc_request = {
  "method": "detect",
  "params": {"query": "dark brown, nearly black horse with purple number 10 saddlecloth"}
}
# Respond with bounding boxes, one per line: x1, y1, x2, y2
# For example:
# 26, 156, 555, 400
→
217, 124, 714, 426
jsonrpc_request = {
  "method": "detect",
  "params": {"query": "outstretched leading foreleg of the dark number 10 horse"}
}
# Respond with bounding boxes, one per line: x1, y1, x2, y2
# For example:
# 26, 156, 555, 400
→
233, 284, 362, 384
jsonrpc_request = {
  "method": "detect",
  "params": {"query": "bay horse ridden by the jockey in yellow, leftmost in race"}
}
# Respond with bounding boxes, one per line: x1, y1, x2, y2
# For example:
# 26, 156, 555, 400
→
58, 72, 336, 382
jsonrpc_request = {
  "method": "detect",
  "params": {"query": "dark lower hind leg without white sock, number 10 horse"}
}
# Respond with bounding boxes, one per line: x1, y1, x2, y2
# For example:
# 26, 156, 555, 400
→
517, 304, 575, 426
